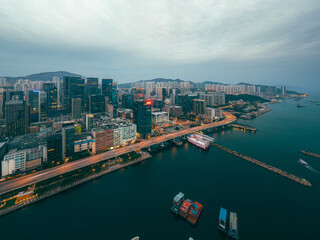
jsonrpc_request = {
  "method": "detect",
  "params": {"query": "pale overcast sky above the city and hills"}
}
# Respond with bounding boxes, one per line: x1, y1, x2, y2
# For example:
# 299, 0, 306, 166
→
0, 0, 320, 92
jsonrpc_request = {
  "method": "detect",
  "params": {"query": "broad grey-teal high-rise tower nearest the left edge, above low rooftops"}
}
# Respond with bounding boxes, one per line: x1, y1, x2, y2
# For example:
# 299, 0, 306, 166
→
5, 100, 30, 137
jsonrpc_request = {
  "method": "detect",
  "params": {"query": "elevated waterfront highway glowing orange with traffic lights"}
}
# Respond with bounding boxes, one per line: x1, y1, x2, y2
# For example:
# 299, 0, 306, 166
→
0, 112, 236, 195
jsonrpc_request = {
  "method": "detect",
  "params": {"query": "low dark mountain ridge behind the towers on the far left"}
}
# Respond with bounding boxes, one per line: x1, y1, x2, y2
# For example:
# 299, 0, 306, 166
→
4, 71, 81, 83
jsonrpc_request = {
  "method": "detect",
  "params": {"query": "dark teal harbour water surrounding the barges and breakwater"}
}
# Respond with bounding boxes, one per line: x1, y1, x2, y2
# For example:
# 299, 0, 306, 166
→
0, 99, 320, 240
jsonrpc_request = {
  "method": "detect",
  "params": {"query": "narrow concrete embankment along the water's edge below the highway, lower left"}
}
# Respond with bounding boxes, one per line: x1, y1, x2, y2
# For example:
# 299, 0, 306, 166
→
0, 152, 152, 216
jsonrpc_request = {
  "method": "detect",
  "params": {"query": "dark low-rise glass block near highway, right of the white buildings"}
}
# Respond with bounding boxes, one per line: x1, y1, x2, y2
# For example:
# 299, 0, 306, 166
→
47, 134, 62, 164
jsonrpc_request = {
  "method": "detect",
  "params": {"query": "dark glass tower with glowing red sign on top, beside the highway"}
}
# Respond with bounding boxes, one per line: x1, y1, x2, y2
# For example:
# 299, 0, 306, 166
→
134, 100, 152, 138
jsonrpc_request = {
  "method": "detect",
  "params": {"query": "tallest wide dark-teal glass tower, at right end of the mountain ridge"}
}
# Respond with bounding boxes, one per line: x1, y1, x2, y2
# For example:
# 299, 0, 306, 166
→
63, 77, 85, 113
